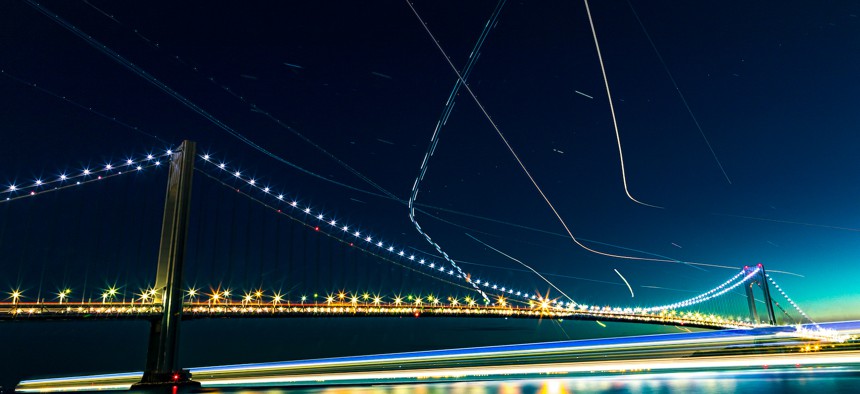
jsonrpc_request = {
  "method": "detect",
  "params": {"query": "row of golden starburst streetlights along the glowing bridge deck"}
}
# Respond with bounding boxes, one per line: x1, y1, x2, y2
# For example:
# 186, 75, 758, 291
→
0, 287, 754, 327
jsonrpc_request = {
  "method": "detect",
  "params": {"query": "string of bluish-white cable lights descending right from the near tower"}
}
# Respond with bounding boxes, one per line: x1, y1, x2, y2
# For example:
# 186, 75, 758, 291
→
200, 154, 544, 306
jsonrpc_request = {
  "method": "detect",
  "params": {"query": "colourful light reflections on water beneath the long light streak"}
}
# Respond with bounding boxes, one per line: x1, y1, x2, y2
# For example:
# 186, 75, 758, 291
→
206, 368, 860, 394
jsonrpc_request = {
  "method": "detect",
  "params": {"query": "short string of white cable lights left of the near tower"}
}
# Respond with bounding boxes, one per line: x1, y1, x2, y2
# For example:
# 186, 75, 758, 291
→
3, 149, 173, 201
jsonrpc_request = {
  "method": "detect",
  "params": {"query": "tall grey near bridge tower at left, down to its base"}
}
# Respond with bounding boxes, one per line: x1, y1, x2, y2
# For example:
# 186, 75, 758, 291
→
134, 140, 200, 389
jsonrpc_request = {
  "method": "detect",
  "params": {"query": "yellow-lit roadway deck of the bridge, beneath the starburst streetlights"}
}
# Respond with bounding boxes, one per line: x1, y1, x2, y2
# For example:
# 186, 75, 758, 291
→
0, 302, 760, 329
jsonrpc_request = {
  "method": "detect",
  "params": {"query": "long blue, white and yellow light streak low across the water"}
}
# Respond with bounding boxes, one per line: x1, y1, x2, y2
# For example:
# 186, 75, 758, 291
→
17, 322, 860, 392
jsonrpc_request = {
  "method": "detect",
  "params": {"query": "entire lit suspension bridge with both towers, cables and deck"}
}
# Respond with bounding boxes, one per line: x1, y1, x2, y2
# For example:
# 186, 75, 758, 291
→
0, 141, 836, 385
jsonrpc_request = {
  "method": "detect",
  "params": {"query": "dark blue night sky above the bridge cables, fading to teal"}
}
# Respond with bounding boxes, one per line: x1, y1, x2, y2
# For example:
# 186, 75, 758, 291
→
0, 0, 860, 384
